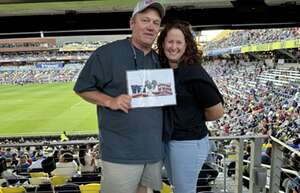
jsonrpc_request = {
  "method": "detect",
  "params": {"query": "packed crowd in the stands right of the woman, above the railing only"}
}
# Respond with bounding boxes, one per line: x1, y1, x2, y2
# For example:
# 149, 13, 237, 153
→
208, 60, 300, 142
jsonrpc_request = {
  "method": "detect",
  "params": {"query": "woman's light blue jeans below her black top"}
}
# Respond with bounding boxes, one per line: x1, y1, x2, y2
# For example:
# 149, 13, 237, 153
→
166, 136, 209, 193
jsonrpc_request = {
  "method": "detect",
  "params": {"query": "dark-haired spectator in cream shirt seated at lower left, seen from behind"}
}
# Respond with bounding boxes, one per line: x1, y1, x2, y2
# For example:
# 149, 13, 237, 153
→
51, 153, 78, 177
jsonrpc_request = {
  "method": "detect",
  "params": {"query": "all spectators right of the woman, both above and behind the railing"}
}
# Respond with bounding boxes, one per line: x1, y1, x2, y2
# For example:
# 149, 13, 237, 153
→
206, 60, 300, 190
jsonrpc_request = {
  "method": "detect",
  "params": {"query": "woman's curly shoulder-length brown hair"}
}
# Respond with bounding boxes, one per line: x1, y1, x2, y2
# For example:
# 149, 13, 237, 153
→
157, 20, 202, 67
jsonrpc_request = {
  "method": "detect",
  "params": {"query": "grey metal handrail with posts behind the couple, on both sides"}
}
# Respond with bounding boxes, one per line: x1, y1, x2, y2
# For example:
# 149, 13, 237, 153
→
0, 135, 299, 193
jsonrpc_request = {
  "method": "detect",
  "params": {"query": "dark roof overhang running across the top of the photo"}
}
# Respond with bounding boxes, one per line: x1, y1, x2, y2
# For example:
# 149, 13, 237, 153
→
0, 0, 300, 38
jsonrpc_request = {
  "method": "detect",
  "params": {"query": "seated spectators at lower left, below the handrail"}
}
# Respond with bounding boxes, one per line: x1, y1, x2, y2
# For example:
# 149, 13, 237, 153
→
0, 144, 101, 190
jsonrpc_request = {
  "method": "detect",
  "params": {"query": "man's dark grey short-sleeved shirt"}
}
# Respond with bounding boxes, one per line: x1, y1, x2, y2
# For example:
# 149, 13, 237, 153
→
74, 39, 163, 164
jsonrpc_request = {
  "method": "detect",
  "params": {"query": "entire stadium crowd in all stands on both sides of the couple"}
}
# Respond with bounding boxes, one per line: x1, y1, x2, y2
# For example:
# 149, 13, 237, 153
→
0, 28, 300, 193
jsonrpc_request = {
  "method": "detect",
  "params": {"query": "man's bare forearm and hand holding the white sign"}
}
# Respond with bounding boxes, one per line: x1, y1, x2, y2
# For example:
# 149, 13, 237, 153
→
76, 91, 131, 113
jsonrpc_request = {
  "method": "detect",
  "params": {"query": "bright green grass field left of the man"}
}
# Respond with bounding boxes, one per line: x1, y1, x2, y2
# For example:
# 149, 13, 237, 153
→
0, 83, 98, 136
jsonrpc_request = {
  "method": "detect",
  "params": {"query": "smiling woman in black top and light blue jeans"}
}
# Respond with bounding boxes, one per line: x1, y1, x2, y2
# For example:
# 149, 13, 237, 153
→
157, 21, 224, 193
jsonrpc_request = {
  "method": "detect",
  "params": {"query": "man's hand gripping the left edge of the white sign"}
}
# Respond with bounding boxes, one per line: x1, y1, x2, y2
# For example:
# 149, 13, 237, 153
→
107, 94, 131, 113
